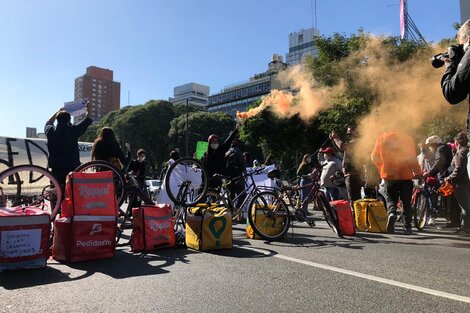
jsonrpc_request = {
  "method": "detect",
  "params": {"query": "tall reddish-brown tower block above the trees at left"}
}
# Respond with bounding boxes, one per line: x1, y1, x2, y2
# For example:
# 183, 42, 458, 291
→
75, 66, 121, 123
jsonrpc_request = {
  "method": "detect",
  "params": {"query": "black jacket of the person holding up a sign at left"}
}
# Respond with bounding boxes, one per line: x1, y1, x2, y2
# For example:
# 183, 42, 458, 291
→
44, 117, 92, 169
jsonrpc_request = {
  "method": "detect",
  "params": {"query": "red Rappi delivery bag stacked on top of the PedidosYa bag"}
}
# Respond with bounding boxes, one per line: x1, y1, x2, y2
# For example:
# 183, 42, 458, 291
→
61, 171, 118, 217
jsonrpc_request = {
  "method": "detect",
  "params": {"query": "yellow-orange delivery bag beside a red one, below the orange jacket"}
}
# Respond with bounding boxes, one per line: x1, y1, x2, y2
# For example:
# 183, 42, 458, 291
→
354, 199, 387, 233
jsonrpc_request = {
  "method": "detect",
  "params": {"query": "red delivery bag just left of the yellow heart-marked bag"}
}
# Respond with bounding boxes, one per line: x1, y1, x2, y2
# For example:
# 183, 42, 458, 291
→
130, 204, 175, 252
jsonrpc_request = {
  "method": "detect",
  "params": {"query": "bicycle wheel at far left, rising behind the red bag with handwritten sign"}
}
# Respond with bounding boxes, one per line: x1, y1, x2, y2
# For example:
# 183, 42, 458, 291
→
0, 165, 62, 219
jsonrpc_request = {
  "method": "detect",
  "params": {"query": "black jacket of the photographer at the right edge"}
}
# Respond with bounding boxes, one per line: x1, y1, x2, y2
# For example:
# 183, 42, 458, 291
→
441, 49, 470, 138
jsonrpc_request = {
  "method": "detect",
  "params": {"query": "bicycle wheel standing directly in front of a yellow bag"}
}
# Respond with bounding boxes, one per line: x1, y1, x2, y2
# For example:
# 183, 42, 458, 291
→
248, 191, 290, 241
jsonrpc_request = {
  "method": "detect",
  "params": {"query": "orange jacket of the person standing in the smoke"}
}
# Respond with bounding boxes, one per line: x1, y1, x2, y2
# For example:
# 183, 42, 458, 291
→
371, 131, 422, 180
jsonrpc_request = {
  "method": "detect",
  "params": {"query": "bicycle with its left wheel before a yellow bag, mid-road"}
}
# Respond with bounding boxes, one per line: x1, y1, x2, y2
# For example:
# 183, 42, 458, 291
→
248, 167, 342, 241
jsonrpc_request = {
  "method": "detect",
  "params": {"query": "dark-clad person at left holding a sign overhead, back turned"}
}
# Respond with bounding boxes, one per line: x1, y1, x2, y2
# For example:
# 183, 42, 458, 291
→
44, 102, 92, 187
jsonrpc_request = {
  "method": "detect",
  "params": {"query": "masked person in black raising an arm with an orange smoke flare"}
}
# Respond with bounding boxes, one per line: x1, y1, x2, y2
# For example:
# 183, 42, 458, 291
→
201, 124, 240, 188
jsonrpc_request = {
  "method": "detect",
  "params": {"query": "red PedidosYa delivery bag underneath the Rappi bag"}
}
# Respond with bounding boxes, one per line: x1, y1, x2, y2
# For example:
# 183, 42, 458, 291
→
52, 215, 117, 263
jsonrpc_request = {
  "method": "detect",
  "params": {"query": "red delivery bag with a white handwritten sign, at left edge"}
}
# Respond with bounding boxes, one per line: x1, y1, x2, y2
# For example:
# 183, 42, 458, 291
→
0, 206, 51, 272
